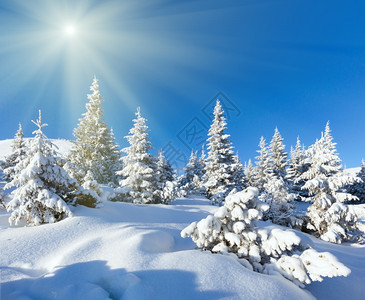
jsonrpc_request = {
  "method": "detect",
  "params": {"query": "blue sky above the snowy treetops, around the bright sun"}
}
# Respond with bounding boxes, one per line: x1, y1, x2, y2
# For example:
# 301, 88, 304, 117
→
0, 0, 365, 167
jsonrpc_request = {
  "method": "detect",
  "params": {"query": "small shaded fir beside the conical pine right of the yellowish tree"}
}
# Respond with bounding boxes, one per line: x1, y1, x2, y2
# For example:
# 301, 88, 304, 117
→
157, 151, 178, 203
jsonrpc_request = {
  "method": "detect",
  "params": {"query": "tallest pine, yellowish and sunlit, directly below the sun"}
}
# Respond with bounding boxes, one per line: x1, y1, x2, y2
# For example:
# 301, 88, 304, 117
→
67, 77, 120, 184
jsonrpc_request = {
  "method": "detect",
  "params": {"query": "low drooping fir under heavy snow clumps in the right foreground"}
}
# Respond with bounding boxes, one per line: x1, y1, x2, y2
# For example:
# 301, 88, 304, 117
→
181, 187, 350, 286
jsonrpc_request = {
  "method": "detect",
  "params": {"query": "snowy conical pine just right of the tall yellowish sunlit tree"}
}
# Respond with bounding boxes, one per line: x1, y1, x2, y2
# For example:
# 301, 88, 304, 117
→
114, 108, 161, 204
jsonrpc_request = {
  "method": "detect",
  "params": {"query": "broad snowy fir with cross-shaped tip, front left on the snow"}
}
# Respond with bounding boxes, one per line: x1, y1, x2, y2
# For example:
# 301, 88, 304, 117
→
5, 111, 96, 225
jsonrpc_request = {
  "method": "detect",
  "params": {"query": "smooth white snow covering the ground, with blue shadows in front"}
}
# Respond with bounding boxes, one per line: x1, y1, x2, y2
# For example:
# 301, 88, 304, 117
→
0, 140, 365, 300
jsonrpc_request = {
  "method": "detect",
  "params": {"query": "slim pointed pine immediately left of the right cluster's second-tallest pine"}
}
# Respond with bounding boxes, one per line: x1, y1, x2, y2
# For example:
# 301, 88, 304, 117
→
253, 136, 273, 192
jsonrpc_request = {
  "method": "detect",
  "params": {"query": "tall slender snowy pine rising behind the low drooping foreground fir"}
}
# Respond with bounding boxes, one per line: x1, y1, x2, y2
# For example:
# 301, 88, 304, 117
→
204, 100, 235, 204
